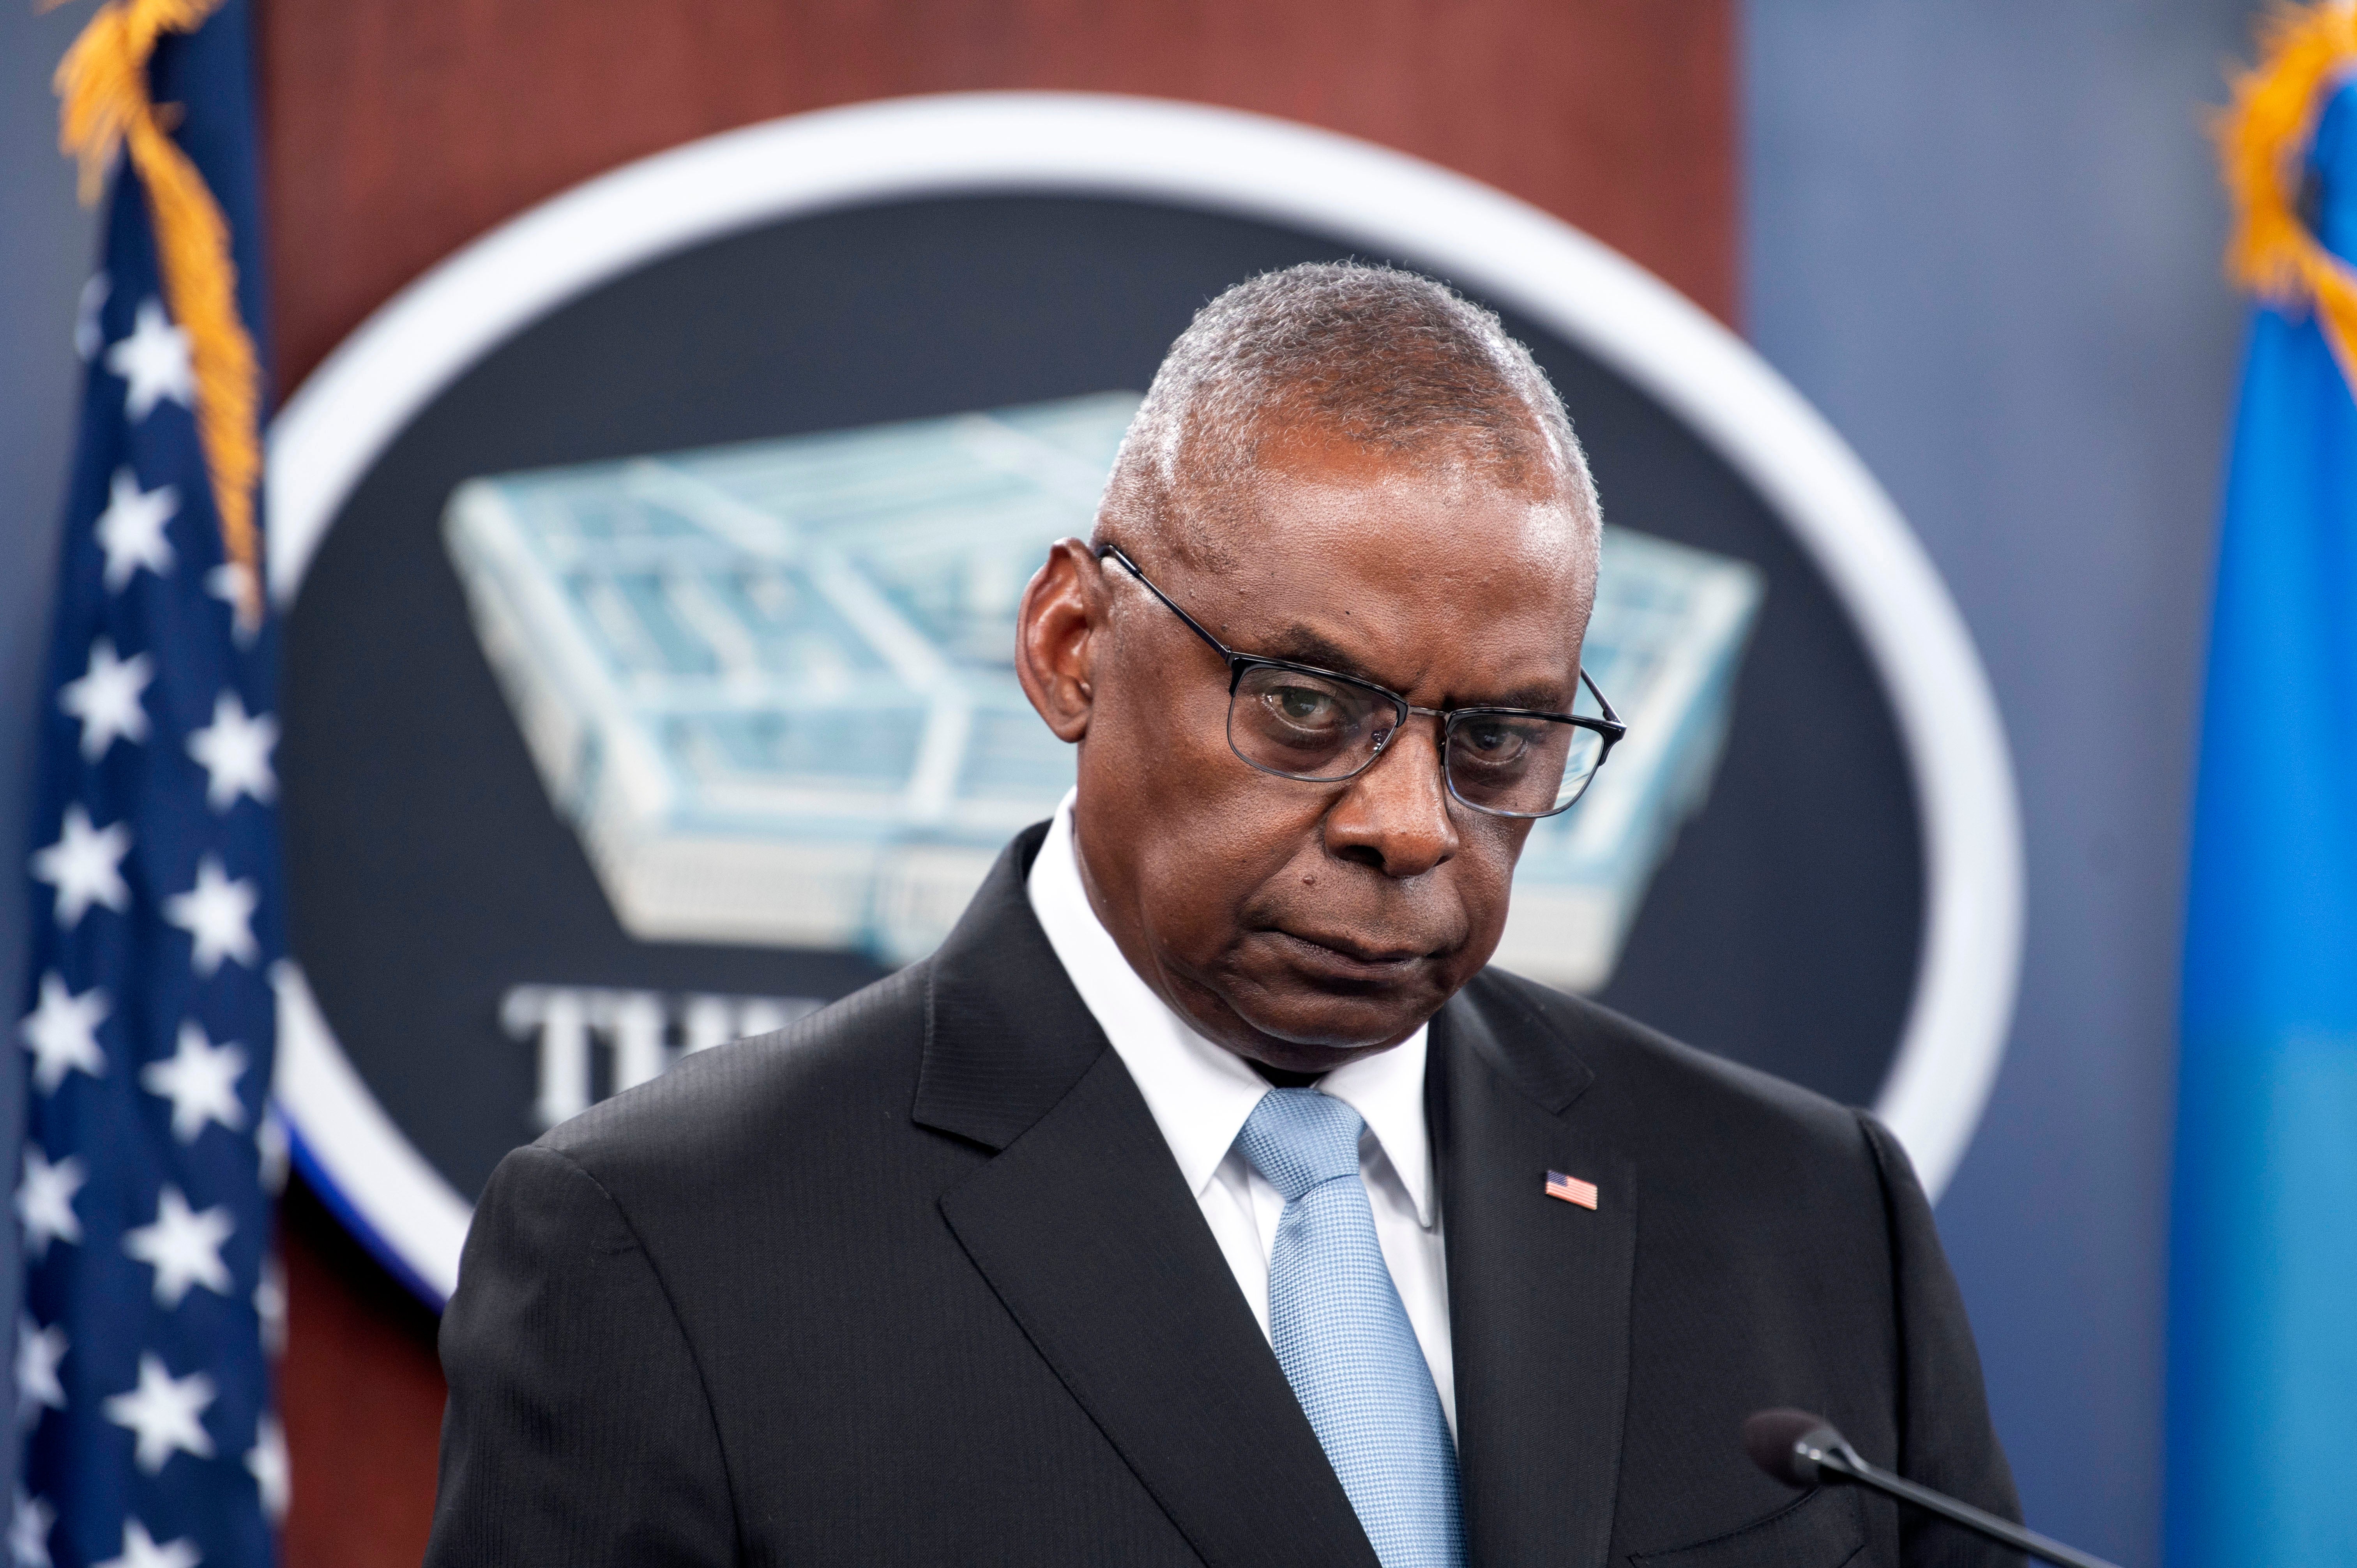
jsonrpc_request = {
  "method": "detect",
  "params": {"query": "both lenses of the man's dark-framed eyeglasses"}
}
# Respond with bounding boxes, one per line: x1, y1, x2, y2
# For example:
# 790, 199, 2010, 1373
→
1228, 665, 1605, 816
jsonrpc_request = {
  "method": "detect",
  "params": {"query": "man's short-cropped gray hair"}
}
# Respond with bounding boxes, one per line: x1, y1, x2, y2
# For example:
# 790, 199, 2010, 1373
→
1096, 262, 1601, 556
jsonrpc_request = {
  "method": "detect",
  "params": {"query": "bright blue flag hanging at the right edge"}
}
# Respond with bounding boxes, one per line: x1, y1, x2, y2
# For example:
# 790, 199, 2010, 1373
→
2168, 78, 2357, 1568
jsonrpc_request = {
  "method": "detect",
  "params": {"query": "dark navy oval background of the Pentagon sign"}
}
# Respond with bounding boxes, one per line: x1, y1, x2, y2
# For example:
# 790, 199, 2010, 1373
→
281, 193, 1921, 1195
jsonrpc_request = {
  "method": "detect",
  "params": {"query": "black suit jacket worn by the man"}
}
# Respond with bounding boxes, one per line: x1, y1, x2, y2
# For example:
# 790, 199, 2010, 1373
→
427, 828, 2015, 1568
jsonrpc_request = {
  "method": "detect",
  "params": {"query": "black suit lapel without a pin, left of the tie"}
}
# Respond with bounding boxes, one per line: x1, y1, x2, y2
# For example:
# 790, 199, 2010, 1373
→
915, 830, 1376, 1568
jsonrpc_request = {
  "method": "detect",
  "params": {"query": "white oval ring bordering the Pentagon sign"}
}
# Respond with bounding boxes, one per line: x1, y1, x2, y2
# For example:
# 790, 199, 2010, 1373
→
266, 92, 2022, 1299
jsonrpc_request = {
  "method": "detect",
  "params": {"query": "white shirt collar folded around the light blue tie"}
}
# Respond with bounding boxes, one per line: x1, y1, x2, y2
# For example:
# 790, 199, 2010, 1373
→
1025, 792, 1433, 1229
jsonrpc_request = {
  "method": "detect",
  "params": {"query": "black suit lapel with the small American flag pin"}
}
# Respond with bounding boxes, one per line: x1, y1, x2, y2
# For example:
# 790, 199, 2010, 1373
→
1426, 995, 1636, 1568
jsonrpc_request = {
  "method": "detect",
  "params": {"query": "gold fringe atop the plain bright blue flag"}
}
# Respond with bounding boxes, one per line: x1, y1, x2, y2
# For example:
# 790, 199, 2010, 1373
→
2213, 0, 2357, 389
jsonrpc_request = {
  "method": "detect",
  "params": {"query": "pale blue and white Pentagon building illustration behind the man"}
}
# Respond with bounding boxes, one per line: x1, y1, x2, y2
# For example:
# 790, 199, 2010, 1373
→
443, 391, 1761, 988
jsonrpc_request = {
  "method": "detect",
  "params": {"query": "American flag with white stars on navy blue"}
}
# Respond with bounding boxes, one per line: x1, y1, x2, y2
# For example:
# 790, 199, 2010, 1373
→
7, 0, 288, 1568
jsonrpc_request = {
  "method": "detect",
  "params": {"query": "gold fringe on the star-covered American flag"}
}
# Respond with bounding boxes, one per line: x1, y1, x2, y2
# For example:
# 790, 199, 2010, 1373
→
57, 0, 261, 625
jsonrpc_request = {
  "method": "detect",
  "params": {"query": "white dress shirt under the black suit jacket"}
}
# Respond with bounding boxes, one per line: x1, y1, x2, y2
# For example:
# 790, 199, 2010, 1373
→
1030, 795, 1457, 1434
